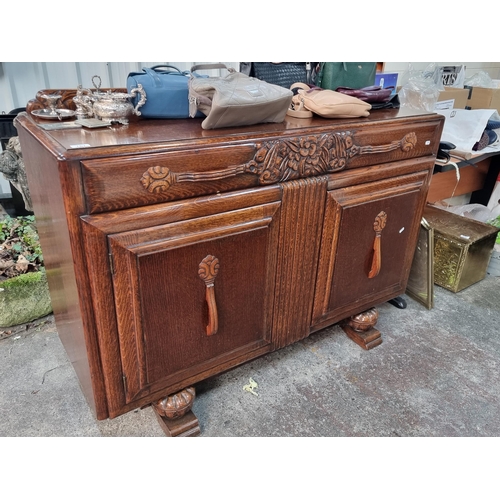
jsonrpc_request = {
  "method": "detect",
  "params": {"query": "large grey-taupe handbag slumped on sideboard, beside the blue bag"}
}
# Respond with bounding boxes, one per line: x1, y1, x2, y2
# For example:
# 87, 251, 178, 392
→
188, 64, 293, 129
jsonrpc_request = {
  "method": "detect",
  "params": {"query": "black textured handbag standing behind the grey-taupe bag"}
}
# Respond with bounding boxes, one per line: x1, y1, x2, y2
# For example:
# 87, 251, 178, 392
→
240, 62, 316, 89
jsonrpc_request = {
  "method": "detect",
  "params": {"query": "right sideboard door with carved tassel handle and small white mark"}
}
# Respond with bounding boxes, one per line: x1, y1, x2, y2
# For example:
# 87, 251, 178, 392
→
312, 172, 429, 329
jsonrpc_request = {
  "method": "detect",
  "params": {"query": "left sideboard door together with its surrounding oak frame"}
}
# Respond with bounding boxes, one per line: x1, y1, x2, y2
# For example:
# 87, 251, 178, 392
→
80, 188, 281, 416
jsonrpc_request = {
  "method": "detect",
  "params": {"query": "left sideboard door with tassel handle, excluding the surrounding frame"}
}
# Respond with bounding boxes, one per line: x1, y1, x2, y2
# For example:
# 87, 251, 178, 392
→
100, 202, 280, 403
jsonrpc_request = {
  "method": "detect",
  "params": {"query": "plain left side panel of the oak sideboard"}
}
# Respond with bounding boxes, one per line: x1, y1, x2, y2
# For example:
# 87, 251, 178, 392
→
18, 127, 108, 419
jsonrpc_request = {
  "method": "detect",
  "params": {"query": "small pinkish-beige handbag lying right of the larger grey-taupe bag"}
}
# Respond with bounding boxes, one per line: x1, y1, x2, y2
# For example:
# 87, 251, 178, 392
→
288, 83, 372, 118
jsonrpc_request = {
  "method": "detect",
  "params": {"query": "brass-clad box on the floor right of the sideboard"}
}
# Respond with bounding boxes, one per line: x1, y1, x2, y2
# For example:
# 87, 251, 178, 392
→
424, 205, 499, 292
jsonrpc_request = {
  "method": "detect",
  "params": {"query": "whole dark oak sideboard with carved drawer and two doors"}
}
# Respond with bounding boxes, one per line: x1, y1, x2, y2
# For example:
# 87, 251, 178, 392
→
15, 100, 444, 436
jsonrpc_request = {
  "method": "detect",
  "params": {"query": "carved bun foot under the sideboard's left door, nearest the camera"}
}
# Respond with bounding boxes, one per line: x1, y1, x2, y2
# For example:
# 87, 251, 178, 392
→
153, 387, 200, 437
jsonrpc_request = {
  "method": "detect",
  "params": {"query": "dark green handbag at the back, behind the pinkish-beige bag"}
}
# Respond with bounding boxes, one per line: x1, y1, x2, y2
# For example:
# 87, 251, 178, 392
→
316, 62, 377, 90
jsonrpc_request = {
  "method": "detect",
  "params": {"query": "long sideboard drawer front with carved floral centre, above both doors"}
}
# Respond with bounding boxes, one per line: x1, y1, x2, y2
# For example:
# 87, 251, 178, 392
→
82, 121, 439, 213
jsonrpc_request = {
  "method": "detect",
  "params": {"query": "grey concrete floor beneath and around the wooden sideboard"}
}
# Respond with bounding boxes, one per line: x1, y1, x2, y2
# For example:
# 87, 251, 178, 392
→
0, 276, 500, 437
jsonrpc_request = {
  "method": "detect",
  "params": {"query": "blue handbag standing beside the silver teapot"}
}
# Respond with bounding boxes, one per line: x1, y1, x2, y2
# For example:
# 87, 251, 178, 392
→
127, 64, 205, 118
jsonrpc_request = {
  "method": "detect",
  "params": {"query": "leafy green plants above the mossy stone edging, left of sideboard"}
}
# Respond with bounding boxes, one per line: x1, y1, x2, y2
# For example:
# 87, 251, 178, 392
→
0, 215, 43, 280
